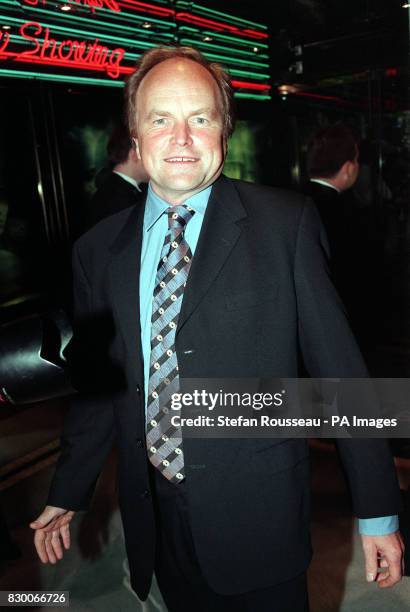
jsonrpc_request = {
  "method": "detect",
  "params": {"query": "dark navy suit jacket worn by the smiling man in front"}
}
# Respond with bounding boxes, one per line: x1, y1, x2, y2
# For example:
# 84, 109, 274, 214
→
44, 171, 399, 598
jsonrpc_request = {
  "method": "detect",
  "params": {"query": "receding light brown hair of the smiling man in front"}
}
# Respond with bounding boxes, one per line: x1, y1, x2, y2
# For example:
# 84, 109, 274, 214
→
125, 47, 235, 142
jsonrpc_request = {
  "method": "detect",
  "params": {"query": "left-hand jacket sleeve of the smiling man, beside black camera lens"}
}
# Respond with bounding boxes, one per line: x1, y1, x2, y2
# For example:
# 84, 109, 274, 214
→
47, 244, 114, 510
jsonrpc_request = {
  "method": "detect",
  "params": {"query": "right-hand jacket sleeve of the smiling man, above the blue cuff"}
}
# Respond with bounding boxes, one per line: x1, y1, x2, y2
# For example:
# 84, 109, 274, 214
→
294, 200, 401, 518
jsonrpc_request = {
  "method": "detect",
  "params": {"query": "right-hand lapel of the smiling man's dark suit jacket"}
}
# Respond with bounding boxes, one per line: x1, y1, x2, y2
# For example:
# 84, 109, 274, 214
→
177, 176, 247, 333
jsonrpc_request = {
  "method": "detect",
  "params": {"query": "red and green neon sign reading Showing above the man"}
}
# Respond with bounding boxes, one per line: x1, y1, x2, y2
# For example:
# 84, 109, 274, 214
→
0, 0, 271, 100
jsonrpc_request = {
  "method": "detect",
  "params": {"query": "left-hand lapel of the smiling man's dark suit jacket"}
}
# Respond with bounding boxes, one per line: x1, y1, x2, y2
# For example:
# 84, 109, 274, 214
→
109, 203, 145, 372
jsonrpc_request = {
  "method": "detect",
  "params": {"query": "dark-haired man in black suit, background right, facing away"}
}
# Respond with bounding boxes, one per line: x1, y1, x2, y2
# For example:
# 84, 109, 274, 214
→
304, 123, 366, 339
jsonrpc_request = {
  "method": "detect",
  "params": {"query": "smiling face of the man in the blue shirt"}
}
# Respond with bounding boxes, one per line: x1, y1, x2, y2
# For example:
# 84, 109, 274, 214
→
136, 58, 225, 204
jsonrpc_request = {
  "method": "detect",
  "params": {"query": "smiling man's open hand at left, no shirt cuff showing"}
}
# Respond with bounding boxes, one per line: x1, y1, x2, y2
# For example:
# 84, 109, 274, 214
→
30, 506, 74, 563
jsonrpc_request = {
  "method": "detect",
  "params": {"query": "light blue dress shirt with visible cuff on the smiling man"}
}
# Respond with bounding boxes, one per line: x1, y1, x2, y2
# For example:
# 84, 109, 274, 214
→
140, 184, 398, 535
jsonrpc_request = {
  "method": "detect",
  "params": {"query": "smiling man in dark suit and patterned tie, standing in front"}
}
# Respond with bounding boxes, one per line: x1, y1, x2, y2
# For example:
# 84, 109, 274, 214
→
31, 47, 402, 612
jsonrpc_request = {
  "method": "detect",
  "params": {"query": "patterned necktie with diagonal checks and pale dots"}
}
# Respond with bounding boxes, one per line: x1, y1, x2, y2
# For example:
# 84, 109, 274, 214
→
147, 205, 195, 482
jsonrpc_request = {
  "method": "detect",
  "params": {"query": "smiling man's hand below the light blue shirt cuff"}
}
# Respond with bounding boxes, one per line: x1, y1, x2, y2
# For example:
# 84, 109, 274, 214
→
362, 531, 404, 588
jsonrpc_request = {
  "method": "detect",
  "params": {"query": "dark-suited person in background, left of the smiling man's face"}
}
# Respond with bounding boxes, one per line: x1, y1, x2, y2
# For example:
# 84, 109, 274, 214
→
89, 124, 149, 227
